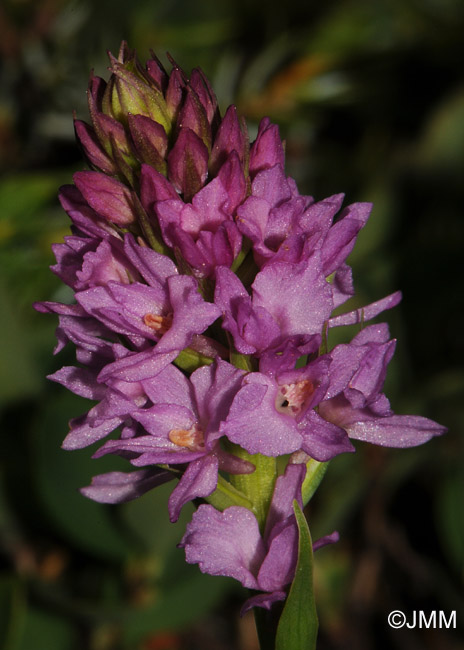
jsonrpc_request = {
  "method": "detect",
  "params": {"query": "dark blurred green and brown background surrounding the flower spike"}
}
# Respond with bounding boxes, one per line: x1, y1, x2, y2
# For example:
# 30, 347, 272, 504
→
0, 0, 464, 650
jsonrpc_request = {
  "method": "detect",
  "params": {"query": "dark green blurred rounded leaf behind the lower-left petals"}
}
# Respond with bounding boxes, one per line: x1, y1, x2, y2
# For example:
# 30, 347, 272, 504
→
33, 392, 129, 559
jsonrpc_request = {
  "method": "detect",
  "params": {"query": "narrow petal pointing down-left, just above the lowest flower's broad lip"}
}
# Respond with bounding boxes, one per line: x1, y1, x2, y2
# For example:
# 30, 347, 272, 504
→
168, 454, 218, 522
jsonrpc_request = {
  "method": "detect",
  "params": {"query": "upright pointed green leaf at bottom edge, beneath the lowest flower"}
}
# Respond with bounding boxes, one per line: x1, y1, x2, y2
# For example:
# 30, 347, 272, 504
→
276, 501, 318, 650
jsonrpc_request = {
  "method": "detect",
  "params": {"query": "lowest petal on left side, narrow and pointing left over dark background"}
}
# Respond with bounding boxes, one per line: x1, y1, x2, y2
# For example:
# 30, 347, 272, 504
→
80, 468, 174, 503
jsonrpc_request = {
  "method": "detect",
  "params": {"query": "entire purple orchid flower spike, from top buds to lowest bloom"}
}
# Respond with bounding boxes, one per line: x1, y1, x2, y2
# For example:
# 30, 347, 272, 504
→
36, 44, 444, 609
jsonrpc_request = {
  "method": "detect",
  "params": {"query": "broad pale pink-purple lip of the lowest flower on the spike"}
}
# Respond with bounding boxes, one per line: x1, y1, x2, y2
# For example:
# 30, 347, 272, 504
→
180, 505, 265, 589
